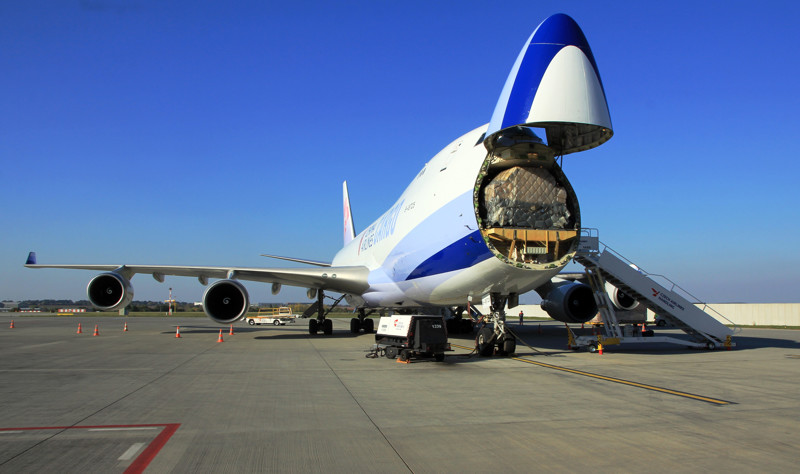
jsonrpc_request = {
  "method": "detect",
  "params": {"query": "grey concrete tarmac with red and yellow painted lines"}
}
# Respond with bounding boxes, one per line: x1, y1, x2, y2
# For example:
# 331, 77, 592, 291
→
0, 313, 800, 473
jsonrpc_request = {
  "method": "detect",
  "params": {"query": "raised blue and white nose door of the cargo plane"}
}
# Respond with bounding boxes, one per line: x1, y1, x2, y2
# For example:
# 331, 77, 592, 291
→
484, 13, 614, 155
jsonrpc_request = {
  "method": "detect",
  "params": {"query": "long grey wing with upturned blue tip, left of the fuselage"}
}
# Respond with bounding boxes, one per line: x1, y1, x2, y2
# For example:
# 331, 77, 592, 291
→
25, 252, 369, 295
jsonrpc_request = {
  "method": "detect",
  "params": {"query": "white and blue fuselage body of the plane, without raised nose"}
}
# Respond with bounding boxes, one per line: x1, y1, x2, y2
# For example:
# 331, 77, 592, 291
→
333, 126, 579, 307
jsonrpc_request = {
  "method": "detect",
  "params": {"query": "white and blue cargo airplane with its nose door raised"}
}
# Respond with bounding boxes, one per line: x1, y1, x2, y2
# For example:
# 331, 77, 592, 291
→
26, 14, 628, 354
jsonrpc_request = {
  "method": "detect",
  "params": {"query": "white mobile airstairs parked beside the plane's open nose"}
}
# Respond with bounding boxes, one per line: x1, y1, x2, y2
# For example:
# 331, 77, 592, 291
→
570, 229, 736, 351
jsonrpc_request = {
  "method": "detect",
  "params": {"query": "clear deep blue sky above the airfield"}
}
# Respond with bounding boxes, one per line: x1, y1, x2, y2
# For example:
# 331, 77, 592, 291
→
0, 0, 800, 302
